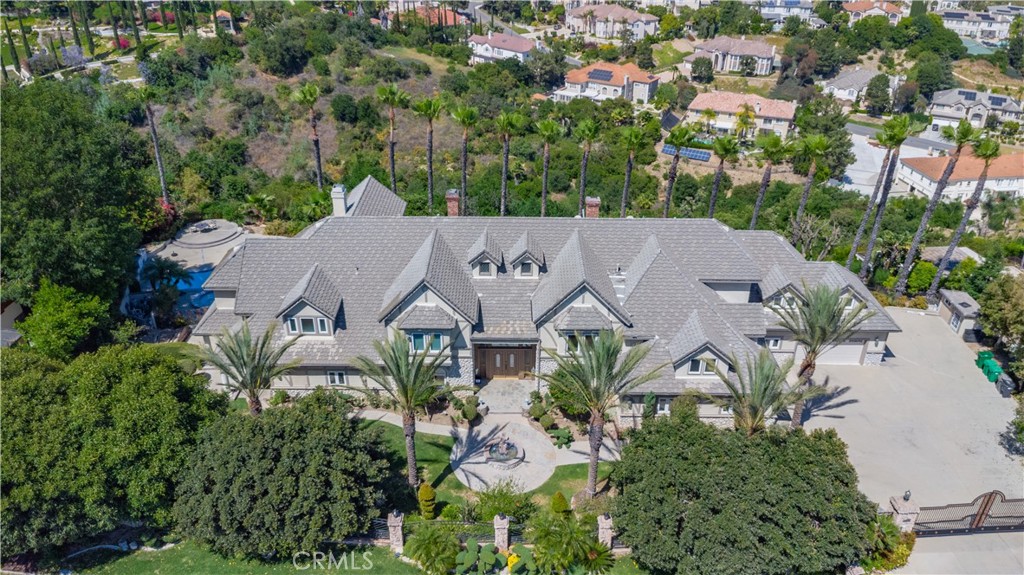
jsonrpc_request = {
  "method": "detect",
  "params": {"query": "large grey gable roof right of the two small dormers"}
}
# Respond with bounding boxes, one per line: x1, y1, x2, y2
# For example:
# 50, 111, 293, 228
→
532, 229, 633, 325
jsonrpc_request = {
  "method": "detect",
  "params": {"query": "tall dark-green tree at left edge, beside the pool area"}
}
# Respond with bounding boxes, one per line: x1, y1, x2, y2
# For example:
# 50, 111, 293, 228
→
0, 80, 156, 303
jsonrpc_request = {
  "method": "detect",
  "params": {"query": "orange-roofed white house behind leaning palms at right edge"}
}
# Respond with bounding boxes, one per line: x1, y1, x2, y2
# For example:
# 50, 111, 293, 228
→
896, 148, 1024, 201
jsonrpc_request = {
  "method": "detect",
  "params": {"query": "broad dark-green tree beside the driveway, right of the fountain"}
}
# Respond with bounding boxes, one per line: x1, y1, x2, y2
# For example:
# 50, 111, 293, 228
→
611, 407, 874, 575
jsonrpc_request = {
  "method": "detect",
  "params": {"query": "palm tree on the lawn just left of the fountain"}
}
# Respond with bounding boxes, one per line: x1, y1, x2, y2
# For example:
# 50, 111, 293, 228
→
349, 329, 469, 489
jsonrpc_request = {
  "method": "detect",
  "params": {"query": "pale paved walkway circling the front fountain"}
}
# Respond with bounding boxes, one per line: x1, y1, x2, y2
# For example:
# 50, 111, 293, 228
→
357, 409, 620, 491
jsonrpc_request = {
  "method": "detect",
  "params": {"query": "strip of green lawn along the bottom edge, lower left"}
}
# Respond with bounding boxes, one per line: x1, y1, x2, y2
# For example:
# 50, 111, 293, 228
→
72, 541, 417, 575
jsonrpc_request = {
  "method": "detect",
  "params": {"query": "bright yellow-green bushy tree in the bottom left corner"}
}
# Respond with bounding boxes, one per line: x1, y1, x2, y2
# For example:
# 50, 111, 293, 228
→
0, 346, 228, 557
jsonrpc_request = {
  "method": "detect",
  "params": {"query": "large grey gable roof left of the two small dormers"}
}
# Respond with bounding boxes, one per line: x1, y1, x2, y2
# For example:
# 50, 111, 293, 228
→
378, 229, 480, 323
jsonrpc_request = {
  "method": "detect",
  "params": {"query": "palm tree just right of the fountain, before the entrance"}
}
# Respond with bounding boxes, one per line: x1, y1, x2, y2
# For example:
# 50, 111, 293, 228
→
538, 329, 665, 496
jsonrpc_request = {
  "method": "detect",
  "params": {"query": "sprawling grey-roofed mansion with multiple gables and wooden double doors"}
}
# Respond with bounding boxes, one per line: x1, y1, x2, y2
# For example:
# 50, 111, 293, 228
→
190, 183, 899, 425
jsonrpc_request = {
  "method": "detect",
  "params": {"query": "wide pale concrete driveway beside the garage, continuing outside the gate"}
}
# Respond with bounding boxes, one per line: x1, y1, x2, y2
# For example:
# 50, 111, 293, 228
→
805, 308, 1024, 575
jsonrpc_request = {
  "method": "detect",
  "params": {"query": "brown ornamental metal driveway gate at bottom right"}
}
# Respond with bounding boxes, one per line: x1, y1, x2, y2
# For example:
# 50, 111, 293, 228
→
913, 491, 1024, 537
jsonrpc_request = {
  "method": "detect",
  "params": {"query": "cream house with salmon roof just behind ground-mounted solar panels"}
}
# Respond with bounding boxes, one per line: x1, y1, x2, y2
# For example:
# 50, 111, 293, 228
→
683, 92, 797, 138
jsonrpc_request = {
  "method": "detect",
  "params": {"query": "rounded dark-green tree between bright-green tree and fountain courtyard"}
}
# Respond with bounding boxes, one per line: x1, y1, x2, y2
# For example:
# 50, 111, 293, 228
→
174, 389, 395, 558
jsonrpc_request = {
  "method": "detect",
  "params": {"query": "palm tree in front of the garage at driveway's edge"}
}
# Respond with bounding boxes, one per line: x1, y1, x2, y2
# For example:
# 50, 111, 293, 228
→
769, 283, 874, 428
